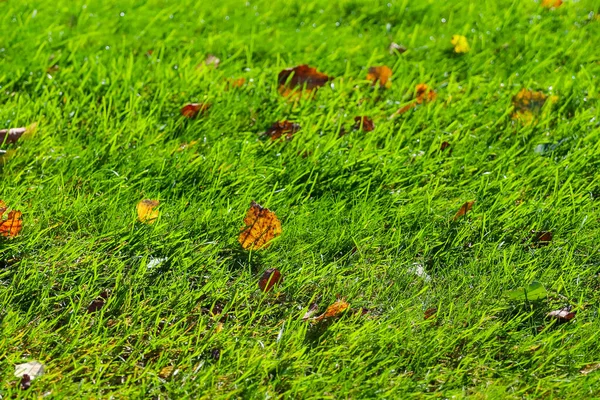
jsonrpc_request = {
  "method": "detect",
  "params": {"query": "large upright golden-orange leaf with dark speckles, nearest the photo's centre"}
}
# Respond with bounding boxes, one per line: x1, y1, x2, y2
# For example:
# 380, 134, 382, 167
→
238, 201, 281, 250
